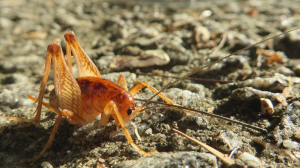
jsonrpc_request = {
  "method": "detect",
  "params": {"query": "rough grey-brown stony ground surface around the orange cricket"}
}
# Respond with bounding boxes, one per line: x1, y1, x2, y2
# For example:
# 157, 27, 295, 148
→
0, 0, 300, 167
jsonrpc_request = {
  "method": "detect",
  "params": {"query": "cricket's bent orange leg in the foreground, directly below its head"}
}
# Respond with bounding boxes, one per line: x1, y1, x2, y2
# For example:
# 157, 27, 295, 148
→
100, 101, 157, 155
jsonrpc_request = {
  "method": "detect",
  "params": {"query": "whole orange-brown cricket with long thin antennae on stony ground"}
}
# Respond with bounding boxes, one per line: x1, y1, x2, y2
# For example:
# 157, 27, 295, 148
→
3, 28, 298, 165
